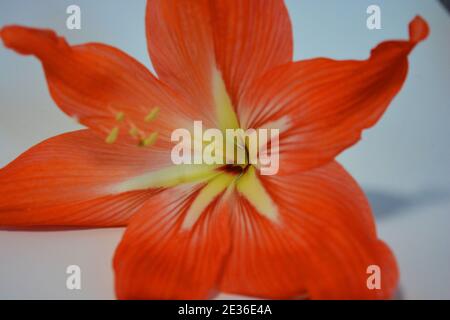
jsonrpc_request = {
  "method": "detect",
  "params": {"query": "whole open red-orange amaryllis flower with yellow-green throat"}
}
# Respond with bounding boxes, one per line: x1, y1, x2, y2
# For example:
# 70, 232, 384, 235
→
0, 0, 428, 299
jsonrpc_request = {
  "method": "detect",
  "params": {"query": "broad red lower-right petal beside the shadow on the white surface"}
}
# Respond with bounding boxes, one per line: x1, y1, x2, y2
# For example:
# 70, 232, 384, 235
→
220, 163, 398, 299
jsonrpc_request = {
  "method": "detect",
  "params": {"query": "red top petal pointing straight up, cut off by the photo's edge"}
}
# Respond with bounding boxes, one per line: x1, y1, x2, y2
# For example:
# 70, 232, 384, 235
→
146, 0, 292, 115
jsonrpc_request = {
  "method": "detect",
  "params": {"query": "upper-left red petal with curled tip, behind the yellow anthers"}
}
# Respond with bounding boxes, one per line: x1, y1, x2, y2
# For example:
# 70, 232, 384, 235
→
0, 26, 190, 141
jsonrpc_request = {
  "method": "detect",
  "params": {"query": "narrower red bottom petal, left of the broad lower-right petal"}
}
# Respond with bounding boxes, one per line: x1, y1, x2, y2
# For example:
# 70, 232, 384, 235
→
114, 181, 229, 299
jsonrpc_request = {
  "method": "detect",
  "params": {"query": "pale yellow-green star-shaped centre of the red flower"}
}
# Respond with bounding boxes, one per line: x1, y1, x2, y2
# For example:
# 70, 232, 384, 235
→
112, 72, 279, 229
